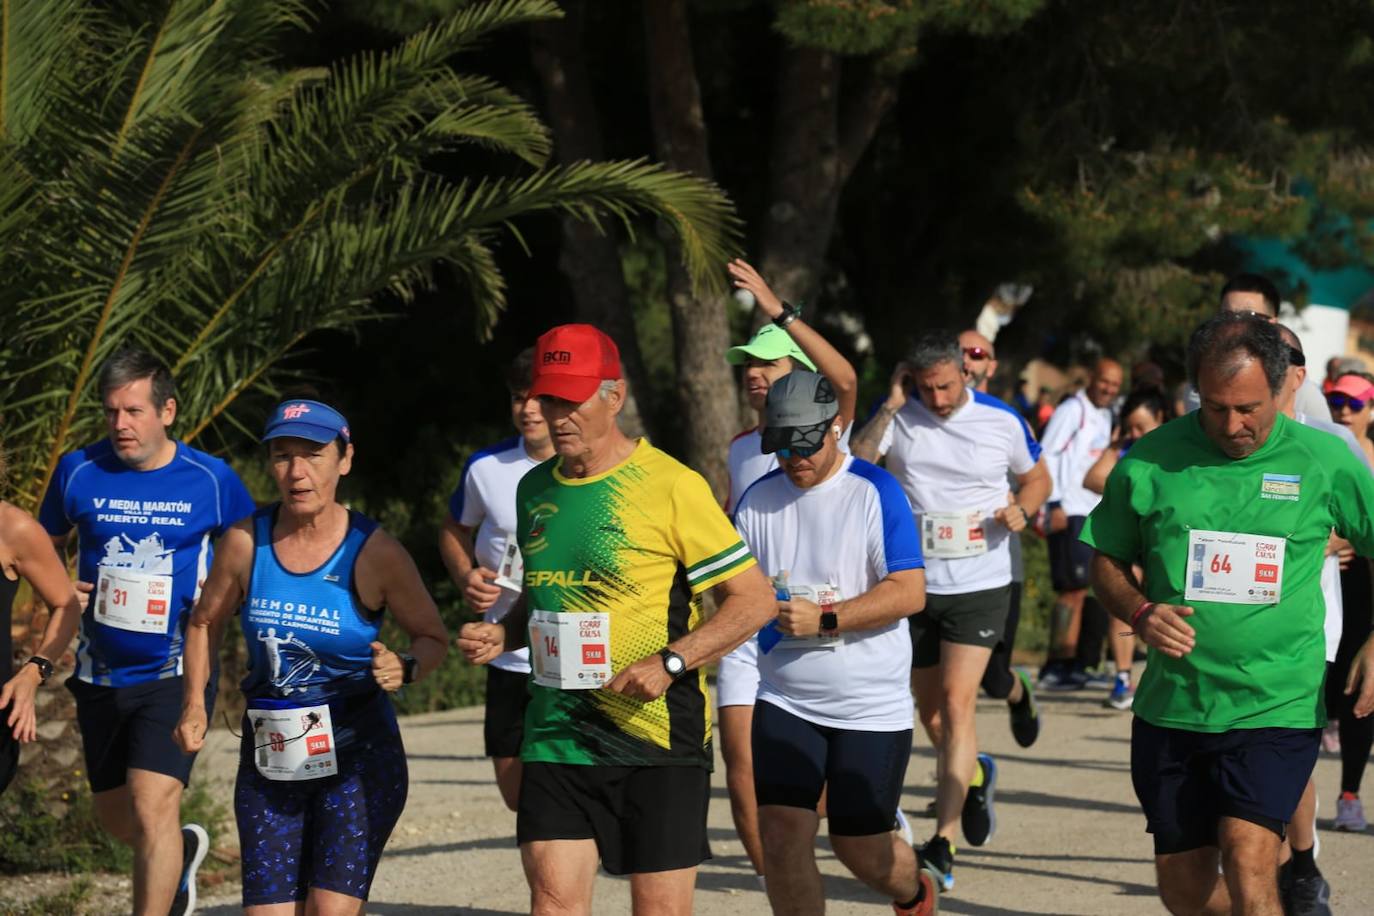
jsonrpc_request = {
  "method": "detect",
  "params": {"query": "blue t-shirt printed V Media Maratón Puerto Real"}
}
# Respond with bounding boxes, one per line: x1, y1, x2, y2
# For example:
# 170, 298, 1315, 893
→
38, 439, 254, 687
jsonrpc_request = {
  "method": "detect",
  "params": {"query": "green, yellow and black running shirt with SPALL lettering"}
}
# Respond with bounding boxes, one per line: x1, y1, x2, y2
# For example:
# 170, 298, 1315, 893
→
515, 439, 754, 769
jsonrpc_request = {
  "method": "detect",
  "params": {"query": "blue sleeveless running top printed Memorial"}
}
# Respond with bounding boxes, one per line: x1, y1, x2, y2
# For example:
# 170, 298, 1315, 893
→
243, 504, 382, 706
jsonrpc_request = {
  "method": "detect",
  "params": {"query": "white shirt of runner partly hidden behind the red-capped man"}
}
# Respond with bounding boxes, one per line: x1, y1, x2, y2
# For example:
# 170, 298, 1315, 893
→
448, 435, 539, 674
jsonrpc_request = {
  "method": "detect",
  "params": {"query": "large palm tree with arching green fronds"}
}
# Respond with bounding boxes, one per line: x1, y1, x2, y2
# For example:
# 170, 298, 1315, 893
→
0, 0, 738, 508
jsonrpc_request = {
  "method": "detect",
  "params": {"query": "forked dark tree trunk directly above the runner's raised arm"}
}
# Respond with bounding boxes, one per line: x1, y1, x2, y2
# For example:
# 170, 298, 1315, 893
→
756, 47, 897, 321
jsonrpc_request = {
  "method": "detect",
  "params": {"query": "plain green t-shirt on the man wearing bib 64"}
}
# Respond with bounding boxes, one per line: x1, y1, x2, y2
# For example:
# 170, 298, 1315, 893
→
1083, 412, 1374, 732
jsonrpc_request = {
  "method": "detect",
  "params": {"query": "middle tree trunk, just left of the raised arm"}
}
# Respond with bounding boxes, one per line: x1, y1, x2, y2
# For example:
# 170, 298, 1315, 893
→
643, 0, 739, 501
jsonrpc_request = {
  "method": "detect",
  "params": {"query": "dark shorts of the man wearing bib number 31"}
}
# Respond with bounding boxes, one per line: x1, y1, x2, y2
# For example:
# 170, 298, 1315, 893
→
66, 669, 220, 792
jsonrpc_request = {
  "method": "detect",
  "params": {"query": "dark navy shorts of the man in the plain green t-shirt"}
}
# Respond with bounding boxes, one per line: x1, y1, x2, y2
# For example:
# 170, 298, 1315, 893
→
1131, 715, 1322, 856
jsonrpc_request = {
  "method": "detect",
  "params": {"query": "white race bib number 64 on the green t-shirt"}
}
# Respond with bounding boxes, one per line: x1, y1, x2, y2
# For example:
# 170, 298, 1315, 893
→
1183, 529, 1287, 604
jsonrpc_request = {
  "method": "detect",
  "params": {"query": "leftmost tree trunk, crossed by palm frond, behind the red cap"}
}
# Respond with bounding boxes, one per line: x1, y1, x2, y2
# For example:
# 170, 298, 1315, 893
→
530, 0, 650, 435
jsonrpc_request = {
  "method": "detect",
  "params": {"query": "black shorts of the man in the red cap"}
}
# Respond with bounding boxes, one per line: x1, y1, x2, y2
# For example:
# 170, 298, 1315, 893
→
515, 762, 710, 875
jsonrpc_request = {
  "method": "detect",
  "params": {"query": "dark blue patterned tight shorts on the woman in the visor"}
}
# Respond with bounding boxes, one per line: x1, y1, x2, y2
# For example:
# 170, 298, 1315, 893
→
234, 721, 409, 906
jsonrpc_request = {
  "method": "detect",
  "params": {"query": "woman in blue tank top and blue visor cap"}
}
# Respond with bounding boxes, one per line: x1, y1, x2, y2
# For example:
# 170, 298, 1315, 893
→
176, 398, 448, 915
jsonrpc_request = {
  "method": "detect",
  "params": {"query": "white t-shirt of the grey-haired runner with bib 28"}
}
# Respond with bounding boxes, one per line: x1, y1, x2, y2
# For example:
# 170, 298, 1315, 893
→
878, 389, 1040, 595
